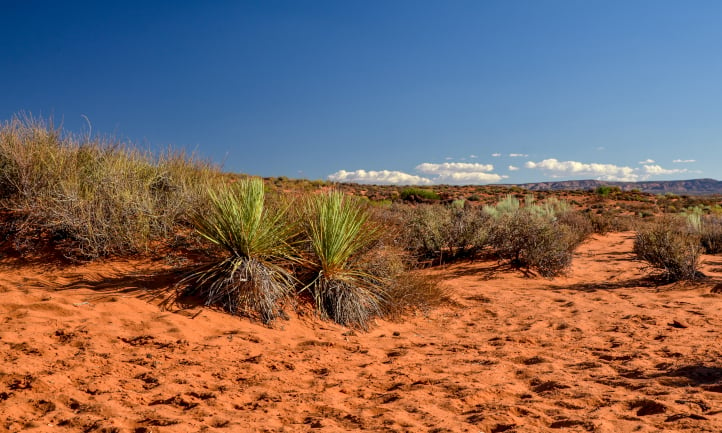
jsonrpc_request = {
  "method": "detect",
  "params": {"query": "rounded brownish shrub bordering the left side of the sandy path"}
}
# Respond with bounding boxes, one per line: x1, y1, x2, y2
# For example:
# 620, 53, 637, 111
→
485, 196, 586, 277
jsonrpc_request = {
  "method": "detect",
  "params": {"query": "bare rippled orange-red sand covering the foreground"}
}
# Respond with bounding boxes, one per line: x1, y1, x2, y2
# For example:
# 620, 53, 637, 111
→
0, 233, 722, 432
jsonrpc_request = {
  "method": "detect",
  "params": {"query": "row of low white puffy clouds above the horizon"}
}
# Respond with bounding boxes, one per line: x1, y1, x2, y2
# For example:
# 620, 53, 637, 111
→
327, 153, 700, 185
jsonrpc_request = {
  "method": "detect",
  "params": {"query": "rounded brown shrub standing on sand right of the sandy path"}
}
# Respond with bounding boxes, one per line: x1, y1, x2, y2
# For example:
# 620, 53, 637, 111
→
634, 217, 701, 281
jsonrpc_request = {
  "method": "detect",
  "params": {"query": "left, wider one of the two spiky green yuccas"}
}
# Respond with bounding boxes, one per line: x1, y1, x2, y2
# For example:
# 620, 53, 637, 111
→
181, 178, 296, 323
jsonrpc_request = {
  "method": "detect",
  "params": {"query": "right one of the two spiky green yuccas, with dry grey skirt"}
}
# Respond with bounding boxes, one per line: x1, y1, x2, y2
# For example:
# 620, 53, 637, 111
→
303, 191, 384, 329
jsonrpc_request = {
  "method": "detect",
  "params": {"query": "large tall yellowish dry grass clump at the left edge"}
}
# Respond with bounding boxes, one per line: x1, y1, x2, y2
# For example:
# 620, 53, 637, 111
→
0, 117, 218, 259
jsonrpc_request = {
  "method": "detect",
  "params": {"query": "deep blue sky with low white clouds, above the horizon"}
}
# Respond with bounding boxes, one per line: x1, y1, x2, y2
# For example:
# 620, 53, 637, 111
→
0, 0, 722, 184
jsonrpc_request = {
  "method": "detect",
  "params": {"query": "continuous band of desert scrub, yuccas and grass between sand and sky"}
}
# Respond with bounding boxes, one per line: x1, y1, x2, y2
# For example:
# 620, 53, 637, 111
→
0, 117, 722, 329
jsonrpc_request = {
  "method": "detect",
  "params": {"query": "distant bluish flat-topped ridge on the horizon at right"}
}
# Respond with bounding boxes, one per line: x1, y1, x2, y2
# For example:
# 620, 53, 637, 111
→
503, 179, 722, 195
